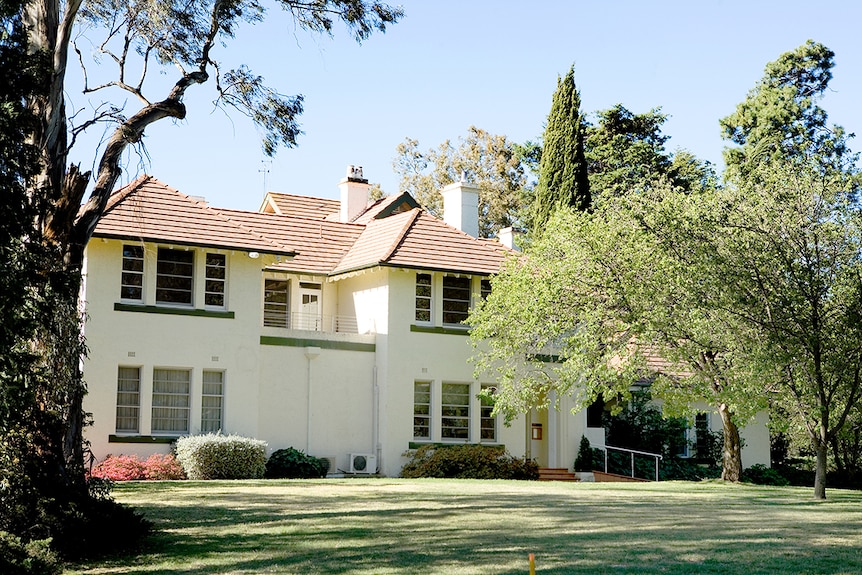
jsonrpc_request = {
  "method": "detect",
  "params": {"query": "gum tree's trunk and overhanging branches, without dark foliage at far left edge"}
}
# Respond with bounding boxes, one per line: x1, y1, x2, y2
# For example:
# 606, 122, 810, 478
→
11, 0, 402, 556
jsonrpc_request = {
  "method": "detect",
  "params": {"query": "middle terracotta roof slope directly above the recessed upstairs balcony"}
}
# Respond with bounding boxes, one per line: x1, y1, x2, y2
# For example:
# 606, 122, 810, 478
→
221, 210, 365, 275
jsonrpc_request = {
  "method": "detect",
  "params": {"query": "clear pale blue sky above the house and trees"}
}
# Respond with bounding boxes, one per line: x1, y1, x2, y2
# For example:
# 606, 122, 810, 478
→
70, 0, 862, 210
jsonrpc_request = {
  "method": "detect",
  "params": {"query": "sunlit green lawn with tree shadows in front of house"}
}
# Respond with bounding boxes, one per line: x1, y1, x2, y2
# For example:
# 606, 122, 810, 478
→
66, 479, 862, 575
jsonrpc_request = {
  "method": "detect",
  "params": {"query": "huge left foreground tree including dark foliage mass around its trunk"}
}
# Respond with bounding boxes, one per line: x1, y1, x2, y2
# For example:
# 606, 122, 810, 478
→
5, 0, 402, 553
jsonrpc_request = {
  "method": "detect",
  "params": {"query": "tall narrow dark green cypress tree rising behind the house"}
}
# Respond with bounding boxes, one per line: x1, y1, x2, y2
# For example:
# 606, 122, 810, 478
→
533, 66, 591, 233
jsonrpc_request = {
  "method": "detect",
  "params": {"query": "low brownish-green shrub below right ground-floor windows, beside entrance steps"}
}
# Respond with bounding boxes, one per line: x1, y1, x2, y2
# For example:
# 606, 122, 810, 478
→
401, 445, 539, 479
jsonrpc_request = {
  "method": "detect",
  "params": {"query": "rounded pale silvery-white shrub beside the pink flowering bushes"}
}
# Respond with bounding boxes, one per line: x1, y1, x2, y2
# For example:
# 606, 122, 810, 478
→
177, 433, 266, 479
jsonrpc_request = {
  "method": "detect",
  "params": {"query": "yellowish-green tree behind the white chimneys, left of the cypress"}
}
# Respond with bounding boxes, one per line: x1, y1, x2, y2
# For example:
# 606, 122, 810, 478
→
392, 126, 527, 237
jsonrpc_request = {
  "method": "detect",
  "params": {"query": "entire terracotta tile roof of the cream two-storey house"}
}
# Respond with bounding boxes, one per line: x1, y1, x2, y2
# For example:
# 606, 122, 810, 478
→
94, 176, 512, 275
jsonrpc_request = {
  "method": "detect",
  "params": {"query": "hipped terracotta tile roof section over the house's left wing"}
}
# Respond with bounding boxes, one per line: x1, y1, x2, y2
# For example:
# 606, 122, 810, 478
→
93, 176, 293, 255
